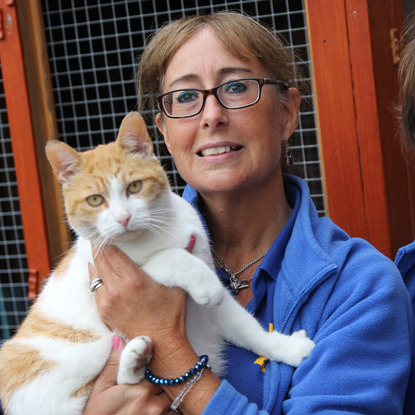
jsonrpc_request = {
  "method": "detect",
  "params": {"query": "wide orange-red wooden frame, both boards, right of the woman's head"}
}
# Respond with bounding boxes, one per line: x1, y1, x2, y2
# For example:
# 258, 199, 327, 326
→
306, 0, 414, 257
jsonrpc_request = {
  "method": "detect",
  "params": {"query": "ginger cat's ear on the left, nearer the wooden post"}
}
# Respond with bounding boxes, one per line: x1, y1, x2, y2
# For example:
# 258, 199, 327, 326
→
46, 140, 81, 183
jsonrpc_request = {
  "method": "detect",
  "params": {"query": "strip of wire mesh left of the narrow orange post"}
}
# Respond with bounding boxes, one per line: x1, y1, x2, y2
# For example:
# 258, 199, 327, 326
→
0, 67, 29, 340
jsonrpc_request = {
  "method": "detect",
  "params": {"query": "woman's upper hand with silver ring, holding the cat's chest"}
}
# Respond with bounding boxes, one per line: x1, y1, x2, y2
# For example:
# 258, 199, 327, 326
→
89, 246, 190, 343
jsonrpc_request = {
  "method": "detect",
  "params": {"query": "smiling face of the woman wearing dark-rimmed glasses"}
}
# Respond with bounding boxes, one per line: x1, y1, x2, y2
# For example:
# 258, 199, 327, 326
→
156, 29, 300, 195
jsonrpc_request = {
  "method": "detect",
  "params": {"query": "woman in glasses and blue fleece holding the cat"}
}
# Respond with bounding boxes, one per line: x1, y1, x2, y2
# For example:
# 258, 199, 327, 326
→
85, 12, 412, 415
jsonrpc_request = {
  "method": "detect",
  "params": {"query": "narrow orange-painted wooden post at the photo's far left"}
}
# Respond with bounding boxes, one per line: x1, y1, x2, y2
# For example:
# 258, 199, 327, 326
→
0, 0, 51, 298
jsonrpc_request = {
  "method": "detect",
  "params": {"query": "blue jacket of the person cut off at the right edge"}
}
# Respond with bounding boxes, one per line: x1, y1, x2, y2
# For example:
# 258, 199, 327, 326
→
395, 241, 415, 415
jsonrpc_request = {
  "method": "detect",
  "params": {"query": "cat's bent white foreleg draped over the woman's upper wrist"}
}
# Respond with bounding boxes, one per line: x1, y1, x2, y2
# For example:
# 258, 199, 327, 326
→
143, 248, 225, 306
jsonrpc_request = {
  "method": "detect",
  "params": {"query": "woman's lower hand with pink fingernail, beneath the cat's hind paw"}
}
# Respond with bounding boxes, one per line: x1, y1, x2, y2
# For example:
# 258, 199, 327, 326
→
83, 337, 175, 415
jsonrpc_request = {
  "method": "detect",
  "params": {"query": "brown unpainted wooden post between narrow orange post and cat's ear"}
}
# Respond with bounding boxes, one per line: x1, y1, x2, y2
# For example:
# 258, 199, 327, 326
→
16, 0, 71, 265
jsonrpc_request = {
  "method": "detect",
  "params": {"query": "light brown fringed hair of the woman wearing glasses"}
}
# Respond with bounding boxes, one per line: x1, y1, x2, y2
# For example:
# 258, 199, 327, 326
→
136, 12, 295, 122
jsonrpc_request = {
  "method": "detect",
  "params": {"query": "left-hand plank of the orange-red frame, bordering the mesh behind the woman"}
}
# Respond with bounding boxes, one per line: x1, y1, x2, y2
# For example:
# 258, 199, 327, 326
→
306, 0, 369, 238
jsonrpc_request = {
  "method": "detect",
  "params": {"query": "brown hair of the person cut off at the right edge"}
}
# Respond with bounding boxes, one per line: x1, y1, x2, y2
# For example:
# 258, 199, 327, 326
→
399, 15, 415, 152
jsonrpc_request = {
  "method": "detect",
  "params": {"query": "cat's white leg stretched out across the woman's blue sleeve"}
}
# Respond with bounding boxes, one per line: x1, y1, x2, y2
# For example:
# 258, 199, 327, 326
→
211, 293, 315, 367
